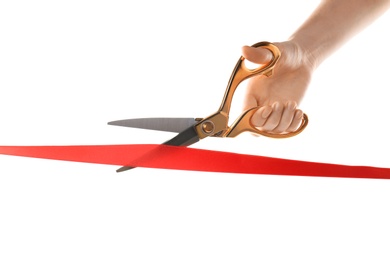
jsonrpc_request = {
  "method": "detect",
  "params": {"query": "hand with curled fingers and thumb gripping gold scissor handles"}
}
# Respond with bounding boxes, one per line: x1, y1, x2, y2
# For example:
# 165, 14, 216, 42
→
242, 41, 314, 134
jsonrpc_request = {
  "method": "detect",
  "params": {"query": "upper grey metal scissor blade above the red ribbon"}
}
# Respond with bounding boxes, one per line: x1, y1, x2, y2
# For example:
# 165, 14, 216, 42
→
108, 117, 196, 133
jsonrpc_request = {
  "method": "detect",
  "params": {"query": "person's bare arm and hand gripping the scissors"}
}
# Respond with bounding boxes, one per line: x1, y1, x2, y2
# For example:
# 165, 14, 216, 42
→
242, 0, 390, 133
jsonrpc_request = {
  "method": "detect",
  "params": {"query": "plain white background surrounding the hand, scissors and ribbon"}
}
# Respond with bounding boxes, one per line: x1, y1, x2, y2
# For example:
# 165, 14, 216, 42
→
0, 0, 390, 260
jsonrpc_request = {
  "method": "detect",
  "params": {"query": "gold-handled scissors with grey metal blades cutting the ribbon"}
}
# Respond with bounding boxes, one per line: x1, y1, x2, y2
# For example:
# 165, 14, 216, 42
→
108, 42, 309, 172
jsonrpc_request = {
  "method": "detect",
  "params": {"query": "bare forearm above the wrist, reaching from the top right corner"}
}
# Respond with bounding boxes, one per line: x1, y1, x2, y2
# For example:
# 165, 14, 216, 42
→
290, 0, 390, 67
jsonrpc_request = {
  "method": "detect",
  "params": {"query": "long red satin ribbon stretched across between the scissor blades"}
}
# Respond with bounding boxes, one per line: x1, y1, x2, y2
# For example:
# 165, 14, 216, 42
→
0, 144, 390, 179
